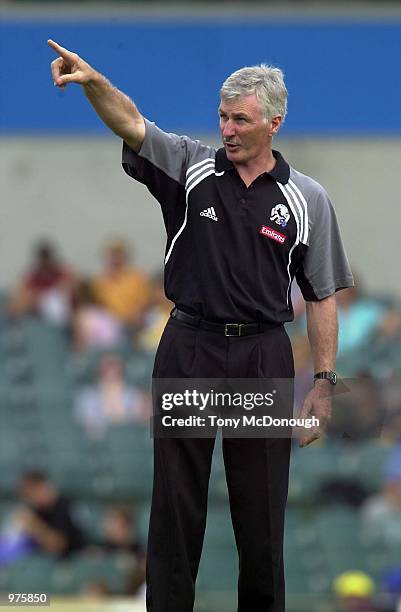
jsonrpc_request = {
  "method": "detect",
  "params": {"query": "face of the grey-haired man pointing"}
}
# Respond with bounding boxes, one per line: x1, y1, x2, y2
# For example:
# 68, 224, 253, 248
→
219, 94, 281, 165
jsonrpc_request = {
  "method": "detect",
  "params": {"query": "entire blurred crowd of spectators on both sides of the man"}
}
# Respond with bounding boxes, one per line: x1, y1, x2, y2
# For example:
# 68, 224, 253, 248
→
0, 239, 401, 612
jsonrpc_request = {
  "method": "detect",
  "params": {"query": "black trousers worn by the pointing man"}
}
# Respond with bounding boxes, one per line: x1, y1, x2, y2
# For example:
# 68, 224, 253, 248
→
146, 319, 294, 612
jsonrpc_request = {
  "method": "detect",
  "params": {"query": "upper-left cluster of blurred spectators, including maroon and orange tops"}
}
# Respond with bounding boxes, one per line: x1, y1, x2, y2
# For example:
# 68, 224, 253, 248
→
7, 239, 172, 436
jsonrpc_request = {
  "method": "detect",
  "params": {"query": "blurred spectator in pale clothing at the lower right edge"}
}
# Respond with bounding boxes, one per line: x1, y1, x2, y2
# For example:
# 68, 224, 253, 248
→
361, 443, 401, 549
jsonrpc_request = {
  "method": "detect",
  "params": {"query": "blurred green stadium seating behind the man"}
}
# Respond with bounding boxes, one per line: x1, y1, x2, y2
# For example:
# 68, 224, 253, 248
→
0, 274, 399, 610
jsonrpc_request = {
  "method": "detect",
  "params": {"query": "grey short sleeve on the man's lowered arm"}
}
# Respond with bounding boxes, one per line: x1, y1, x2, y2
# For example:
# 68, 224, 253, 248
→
296, 188, 354, 301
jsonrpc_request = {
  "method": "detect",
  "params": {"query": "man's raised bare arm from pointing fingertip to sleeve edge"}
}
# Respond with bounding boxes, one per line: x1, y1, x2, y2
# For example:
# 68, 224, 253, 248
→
47, 40, 145, 153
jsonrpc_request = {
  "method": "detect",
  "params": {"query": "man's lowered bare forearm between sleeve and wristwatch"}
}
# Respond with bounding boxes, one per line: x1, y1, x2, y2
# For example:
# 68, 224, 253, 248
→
306, 295, 338, 373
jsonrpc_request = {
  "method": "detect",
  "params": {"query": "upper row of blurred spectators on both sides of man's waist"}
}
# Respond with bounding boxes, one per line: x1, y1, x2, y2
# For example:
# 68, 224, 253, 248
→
7, 239, 401, 377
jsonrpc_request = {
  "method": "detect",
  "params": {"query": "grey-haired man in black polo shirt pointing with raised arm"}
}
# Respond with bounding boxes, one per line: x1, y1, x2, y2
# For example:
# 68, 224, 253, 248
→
49, 41, 353, 612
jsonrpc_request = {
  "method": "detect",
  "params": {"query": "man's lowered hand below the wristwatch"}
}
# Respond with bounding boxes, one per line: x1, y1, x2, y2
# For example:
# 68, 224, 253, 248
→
297, 380, 332, 448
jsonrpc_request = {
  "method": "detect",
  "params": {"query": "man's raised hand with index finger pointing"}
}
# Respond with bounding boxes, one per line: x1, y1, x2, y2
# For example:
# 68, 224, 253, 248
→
47, 40, 94, 88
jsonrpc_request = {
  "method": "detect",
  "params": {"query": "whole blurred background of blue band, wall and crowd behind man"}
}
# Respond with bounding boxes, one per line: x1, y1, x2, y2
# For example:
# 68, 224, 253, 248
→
0, 0, 401, 612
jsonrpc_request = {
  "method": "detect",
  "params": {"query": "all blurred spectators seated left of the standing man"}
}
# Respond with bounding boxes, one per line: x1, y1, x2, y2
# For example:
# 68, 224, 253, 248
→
0, 239, 172, 596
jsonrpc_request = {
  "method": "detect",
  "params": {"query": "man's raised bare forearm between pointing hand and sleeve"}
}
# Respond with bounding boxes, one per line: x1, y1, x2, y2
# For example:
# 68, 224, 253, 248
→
82, 70, 145, 151
